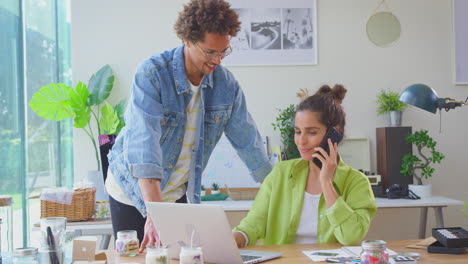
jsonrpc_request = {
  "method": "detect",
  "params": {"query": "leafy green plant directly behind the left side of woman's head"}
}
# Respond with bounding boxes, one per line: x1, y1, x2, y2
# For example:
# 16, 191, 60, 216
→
271, 104, 301, 160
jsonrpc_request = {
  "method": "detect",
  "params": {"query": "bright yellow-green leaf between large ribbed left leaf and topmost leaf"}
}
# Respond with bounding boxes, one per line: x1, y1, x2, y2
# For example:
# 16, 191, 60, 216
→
70, 82, 91, 128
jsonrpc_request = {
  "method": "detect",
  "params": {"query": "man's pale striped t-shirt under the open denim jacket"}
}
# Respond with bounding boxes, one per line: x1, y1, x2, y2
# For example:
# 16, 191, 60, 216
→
106, 82, 202, 206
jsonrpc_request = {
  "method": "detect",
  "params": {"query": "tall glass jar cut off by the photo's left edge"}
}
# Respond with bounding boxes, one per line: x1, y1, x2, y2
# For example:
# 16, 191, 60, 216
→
0, 195, 13, 254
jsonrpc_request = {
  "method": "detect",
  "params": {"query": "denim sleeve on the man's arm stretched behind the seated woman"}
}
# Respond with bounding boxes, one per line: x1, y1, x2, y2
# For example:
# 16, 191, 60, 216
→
224, 81, 273, 182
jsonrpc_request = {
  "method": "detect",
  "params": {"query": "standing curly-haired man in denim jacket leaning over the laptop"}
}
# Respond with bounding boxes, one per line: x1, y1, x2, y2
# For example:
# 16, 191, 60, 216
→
106, 0, 272, 252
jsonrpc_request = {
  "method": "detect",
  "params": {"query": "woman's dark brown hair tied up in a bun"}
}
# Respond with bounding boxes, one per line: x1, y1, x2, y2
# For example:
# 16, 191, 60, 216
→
296, 84, 347, 134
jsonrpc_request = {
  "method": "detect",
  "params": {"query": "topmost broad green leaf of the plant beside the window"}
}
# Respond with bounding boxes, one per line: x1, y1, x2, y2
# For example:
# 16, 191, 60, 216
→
88, 64, 114, 105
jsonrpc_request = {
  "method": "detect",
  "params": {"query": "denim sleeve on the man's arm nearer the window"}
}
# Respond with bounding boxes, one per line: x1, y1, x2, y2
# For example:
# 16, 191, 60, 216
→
124, 64, 163, 179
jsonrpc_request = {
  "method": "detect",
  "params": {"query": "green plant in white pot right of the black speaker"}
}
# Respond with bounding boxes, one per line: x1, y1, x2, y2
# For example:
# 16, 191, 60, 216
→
400, 130, 445, 197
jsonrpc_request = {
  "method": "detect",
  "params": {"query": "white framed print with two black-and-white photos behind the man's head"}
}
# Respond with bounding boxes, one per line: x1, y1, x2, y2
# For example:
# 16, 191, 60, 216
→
223, 0, 317, 65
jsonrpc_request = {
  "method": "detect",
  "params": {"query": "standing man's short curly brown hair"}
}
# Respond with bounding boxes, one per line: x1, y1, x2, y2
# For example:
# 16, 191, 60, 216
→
174, 0, 240, 42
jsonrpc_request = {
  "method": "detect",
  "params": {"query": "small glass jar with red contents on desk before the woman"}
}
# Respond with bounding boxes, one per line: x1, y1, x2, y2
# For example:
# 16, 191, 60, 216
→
361, 240, 389, 264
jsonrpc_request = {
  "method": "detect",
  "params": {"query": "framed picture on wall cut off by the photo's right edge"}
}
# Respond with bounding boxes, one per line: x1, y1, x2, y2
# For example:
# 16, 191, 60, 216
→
453, 0, 468, 84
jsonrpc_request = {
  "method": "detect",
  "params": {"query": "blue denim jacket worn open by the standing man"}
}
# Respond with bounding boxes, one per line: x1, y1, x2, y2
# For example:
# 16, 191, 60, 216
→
108, 46, 273, 217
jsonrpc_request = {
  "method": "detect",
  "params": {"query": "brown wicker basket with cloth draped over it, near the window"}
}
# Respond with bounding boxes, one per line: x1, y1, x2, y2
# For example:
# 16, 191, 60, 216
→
41, 188, 96, 222
